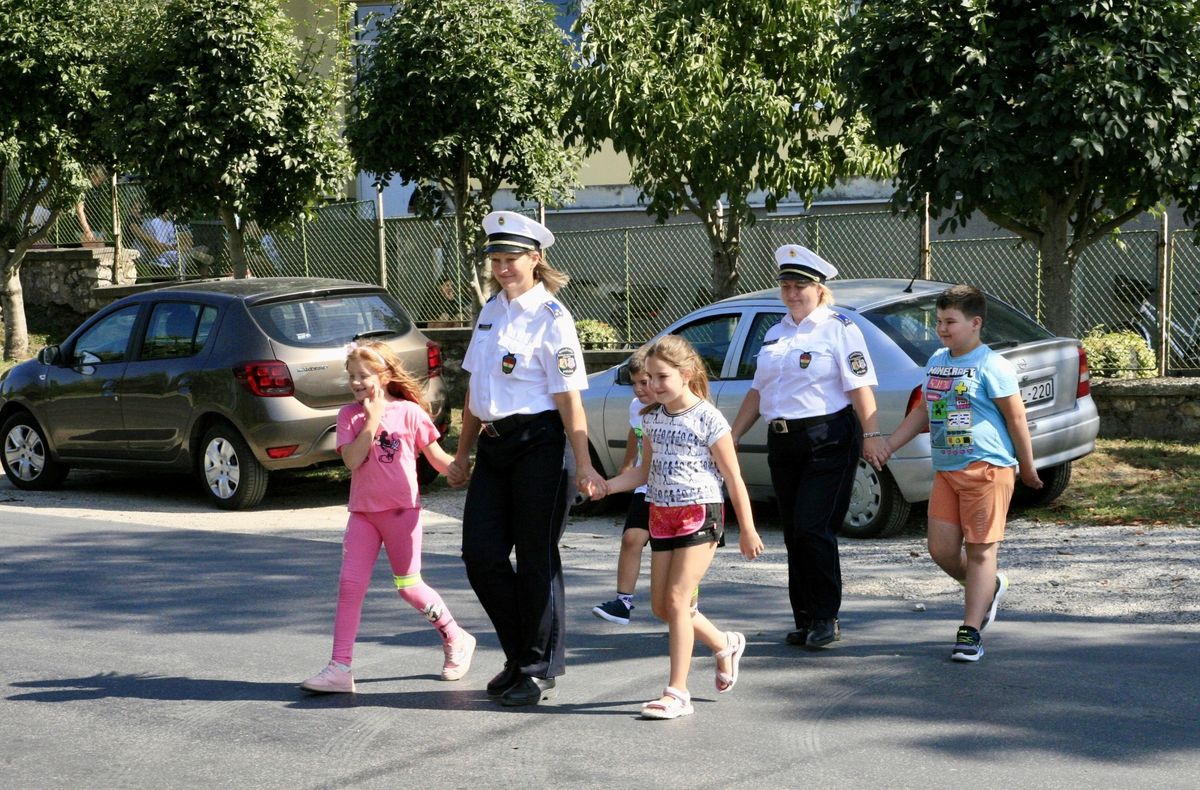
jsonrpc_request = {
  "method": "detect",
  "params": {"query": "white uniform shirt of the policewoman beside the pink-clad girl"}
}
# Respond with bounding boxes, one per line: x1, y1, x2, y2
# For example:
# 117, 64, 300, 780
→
462, 282, 588, 423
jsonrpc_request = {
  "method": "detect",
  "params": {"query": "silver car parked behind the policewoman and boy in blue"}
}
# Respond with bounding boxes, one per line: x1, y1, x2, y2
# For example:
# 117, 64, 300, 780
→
583, 280, 1099, 538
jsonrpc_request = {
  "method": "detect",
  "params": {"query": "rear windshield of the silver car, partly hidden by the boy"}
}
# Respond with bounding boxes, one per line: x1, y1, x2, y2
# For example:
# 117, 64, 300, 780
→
863, 294, 1054, 365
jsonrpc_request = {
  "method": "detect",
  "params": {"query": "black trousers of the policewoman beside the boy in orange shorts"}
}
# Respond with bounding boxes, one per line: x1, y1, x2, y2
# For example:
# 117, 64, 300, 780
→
767, 407, 863, 628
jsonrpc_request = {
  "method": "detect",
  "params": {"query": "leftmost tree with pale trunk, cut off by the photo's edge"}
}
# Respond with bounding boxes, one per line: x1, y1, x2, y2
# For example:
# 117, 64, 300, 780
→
0, 0, 120, 359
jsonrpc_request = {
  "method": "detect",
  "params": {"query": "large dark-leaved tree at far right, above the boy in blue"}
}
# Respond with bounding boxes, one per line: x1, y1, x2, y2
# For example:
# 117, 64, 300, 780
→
846, 0, 1200, 335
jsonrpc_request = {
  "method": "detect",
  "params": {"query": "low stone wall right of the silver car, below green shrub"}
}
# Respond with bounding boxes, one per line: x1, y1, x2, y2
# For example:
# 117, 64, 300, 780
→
1092, 378, 1200, 442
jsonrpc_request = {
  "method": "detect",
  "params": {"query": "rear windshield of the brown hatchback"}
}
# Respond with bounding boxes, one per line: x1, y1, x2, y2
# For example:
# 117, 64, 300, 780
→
250, 293, 413, 348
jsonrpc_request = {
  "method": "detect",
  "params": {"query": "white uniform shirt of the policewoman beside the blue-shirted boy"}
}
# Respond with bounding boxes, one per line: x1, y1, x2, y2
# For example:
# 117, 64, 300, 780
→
754, 305, 877, 420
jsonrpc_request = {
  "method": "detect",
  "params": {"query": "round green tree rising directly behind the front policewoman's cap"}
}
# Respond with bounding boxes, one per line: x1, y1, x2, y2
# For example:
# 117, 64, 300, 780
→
347, 0, 578, 299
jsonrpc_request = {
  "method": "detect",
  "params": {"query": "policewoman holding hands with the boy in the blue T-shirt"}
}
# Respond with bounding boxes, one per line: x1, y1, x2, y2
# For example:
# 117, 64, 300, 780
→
732, 244, 887, 647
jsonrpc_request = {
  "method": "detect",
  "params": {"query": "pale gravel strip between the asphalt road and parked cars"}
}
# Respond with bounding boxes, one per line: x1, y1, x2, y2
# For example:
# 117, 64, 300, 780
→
0, 472, 1200, 624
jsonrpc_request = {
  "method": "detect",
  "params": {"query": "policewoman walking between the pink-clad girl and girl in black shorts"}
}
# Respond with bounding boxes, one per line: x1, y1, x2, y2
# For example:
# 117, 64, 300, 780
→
448, 211, 605, 706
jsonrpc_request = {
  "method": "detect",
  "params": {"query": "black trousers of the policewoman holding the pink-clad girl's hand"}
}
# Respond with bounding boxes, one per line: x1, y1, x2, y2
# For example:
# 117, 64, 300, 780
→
462, 411, 575, 677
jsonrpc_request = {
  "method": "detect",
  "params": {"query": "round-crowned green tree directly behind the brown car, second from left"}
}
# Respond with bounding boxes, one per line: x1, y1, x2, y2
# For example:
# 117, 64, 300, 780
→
110, 0, 349, 277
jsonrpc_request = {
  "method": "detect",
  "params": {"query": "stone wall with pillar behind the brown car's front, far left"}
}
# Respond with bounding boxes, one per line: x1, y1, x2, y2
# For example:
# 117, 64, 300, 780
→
20, 242, 137, 323
